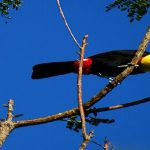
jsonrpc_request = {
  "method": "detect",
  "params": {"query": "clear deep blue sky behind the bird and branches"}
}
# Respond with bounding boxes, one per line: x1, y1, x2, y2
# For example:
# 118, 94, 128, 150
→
0, 0, 150, 150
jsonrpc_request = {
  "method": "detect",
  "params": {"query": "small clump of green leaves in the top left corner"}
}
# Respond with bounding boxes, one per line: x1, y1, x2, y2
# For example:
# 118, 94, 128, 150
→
0, 0, 22, 18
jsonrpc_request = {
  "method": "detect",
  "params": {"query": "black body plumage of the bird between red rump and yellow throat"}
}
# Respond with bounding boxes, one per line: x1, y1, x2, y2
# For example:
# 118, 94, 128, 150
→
90, 50, 150, 77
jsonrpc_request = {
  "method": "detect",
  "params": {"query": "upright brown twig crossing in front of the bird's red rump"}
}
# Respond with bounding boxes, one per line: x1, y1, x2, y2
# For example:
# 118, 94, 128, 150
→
77, 35, 88, 139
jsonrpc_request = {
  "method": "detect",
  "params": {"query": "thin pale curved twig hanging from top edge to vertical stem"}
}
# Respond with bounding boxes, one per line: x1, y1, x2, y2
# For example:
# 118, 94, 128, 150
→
56, 0, 81, 48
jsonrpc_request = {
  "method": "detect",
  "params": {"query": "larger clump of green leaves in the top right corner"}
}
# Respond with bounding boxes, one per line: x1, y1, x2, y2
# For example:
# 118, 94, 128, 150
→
106, 0, 150, 22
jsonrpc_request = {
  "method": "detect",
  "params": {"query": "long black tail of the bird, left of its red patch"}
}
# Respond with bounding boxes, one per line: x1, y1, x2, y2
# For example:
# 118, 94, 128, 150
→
32, 61, 74, 79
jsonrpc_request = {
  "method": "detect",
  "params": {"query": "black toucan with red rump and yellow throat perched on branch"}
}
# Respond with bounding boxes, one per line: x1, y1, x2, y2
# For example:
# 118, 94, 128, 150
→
32, 50, 150, 79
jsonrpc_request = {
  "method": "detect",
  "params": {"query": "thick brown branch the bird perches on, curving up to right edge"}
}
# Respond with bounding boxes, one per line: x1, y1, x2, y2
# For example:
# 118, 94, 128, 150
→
14, 28, 150, 128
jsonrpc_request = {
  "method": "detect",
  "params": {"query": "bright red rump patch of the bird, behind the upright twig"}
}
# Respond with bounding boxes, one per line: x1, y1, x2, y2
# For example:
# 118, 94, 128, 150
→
73, 58, 92, 74
